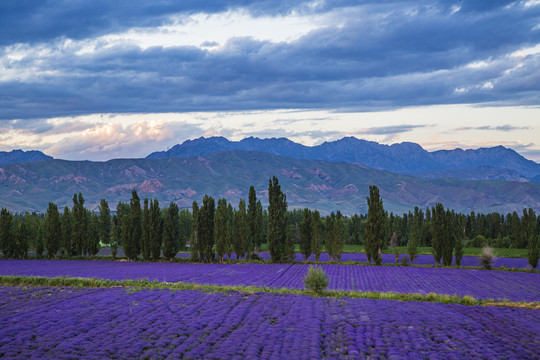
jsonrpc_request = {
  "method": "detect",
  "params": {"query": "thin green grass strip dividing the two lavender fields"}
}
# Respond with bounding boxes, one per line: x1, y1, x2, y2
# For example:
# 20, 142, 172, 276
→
0, 276, 540, 310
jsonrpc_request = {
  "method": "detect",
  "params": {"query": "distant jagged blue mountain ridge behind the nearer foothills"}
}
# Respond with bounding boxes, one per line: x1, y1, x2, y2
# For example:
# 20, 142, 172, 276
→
147, 137, 540, 182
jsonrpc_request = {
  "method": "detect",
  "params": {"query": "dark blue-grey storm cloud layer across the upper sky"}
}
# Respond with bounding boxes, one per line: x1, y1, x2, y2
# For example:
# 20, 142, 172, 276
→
0, 1, 540, 119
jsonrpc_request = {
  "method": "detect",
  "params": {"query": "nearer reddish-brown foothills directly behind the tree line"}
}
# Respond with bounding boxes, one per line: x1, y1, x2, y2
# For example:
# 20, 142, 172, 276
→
0, 148, 540, 214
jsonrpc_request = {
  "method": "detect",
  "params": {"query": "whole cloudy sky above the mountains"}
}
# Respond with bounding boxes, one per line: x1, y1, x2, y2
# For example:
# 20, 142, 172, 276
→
0, 0, 540, 162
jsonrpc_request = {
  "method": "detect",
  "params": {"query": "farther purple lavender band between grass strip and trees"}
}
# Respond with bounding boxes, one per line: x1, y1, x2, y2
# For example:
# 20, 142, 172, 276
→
0, 260, 540, 301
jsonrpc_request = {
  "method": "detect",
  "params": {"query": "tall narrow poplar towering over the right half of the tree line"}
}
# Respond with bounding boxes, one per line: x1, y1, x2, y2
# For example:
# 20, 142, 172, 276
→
364, 185, 385, 265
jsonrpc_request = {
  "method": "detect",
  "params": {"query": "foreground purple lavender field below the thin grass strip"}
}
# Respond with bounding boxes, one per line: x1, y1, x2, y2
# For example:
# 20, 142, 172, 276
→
0, 287, 540, 359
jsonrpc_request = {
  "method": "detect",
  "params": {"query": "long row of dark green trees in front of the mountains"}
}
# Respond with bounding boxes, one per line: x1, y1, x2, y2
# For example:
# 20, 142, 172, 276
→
0, 177, 540, 265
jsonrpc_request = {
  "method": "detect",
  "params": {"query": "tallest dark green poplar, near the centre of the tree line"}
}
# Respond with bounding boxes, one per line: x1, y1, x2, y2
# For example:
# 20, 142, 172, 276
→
267, 176, 287, 262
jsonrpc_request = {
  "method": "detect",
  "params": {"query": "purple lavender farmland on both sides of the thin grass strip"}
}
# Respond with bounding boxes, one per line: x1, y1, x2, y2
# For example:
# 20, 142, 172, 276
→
0, 259, 540, 359
